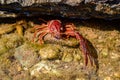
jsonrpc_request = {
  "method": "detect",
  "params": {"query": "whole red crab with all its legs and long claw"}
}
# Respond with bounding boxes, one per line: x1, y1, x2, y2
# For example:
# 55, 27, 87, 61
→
33, 20, 93, 66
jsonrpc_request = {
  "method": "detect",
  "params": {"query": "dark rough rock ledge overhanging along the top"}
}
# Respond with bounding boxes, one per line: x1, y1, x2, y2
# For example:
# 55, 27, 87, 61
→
0, 0, 120, 19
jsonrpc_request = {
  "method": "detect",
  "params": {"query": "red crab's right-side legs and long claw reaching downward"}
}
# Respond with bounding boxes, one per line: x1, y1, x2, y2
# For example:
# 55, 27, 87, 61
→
63, 23, 93, 66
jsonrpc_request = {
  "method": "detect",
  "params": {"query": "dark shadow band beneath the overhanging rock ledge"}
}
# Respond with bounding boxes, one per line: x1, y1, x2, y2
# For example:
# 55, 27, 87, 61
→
0, 15, 120, 31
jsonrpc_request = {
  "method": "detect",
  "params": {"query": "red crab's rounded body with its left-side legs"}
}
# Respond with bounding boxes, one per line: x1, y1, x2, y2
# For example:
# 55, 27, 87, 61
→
33, 20, 61, 44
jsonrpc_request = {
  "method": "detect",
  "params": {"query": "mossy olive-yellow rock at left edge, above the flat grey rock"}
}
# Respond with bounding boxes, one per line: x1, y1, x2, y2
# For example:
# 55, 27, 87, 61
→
0, 34, 24, 55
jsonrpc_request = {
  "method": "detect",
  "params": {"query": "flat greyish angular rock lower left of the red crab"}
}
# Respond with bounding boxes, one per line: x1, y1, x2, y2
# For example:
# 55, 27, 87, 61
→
14, 43, 40, 68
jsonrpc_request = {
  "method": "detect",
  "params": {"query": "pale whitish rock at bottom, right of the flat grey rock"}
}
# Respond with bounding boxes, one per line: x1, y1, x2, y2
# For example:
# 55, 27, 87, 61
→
30, 61, 61, 77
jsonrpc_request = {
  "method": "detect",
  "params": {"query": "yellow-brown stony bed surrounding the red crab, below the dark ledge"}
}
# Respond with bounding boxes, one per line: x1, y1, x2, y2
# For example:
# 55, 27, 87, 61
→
0, 18, 120, 80
